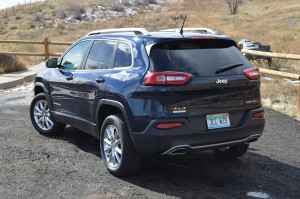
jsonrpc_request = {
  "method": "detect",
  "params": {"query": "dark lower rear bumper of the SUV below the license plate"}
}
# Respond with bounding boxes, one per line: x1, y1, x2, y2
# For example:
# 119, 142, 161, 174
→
131, 109, 265, 155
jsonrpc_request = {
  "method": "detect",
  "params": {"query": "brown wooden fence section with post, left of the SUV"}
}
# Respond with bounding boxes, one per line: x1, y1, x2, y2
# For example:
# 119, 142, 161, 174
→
0, 38, 73, 60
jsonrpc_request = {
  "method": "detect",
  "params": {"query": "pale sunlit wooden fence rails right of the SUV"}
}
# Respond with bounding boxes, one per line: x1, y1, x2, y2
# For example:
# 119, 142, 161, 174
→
239, 45, 300, 117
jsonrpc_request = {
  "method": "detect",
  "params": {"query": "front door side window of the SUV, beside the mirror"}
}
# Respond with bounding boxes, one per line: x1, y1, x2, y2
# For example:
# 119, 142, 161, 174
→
61, 41, 90, 70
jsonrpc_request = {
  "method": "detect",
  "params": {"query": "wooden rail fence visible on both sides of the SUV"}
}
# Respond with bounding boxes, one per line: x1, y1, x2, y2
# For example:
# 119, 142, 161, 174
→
0, 38, 300, 117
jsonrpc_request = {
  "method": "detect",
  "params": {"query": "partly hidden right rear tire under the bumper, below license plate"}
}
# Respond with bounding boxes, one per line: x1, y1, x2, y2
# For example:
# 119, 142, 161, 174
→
213, 143, 249, 159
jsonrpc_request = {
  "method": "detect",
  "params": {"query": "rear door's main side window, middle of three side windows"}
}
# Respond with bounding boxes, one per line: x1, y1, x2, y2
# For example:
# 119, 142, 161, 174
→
85, 40, 116, 69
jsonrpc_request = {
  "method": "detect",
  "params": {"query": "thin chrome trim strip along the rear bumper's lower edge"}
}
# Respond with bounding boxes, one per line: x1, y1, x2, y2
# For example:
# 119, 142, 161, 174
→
162, 134, 260, 155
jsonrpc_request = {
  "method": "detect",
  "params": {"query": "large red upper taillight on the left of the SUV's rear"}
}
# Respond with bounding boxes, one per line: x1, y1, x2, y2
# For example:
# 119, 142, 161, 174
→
145, 72, 191, 85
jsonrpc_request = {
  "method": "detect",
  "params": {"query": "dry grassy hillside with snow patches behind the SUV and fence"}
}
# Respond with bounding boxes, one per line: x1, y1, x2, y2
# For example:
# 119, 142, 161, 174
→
0, 0, 300, 54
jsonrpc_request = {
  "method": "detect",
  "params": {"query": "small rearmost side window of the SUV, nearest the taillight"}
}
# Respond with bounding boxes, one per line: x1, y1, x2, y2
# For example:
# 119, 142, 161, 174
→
115, 42, 132, 67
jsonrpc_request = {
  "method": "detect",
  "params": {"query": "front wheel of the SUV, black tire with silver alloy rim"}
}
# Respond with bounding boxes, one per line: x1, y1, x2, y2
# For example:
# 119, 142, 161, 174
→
30, 93, 66, 135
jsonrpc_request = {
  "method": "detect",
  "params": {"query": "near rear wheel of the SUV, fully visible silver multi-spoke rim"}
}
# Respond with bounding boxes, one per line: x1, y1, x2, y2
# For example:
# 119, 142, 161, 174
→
100, 115, 141, 177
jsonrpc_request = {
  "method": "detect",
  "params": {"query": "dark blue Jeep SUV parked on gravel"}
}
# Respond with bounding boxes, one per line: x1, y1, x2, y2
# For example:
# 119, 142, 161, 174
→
30, 28, 265, 176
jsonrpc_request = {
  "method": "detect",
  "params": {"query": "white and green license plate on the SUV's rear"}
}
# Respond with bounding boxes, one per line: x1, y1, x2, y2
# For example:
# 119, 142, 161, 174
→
206, 113, 230, 129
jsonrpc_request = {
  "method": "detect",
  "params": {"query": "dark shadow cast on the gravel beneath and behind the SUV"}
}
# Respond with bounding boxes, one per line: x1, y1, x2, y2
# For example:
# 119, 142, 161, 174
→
52, 127, 300, 198
